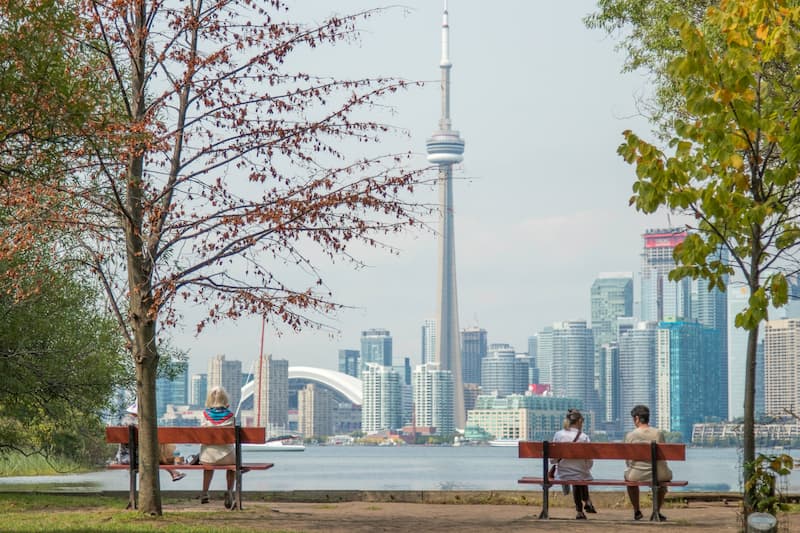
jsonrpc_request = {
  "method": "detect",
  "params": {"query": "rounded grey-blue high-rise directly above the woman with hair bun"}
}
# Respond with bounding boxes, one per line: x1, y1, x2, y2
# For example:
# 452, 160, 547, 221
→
551, 320, 598, 412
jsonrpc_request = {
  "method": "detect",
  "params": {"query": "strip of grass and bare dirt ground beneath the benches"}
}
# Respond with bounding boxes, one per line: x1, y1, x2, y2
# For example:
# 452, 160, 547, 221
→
0, 491, 800, 533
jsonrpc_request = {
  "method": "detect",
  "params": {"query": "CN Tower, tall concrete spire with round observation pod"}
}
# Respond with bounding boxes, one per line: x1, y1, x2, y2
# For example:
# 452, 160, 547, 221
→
427, 0, 467, 429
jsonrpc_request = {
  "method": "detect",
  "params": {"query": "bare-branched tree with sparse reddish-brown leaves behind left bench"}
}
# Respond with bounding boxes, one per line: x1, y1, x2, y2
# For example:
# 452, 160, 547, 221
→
0, 0, 424, 515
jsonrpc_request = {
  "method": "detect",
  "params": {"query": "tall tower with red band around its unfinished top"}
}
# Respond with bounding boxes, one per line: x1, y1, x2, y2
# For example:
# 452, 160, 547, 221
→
640, 228, 691, 321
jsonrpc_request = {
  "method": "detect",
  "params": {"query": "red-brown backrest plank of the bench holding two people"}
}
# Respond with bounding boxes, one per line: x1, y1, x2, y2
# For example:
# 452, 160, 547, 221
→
519, 441, 686, 461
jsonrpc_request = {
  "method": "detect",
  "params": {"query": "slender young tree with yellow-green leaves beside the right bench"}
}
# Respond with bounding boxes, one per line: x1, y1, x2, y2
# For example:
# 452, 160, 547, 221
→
608, 0, 800, 512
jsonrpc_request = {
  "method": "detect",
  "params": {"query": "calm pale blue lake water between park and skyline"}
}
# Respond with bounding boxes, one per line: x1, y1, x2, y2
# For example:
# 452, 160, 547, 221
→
0, 446, 800, 493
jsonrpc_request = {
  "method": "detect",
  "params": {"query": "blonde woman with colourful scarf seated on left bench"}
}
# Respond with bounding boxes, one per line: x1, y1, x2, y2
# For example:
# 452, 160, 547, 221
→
200, 387, 236, 509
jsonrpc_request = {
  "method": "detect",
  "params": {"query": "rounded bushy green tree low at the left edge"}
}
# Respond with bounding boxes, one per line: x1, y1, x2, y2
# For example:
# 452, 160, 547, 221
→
0, 251, 126, 464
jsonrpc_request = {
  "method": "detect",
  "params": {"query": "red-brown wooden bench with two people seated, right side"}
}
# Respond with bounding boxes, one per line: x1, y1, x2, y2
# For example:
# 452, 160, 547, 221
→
517, 441, 689, 522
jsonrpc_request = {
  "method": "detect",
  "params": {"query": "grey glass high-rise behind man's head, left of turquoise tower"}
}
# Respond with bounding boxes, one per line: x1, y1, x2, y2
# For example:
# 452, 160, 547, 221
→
619, 322, 658, 424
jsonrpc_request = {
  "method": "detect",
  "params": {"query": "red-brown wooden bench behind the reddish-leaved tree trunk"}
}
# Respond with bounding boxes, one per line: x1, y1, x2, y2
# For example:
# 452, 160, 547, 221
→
106, 426, 274, 509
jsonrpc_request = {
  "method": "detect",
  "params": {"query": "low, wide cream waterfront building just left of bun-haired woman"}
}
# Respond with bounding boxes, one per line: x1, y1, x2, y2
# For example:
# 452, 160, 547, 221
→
467, 394, 593, 441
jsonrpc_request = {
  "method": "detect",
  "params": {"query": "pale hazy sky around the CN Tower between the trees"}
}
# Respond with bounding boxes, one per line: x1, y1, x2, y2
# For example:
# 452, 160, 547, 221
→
174, 0, 668, 373
